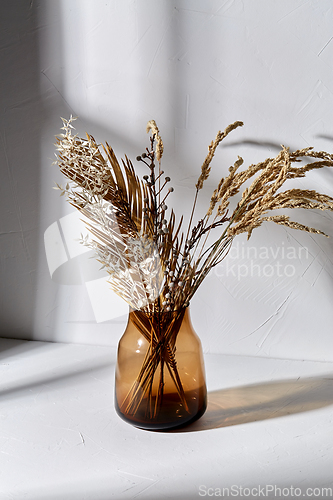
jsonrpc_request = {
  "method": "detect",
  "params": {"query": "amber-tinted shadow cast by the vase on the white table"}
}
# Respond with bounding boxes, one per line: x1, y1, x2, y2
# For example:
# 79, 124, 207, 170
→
174, 374, 333, 432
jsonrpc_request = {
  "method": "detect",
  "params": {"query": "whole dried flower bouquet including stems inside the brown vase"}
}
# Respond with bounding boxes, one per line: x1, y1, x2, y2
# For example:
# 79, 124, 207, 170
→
55, 117, 333, 417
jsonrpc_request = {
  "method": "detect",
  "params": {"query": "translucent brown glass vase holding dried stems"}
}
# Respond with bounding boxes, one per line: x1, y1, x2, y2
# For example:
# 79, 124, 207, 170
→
115, 308, 207, 430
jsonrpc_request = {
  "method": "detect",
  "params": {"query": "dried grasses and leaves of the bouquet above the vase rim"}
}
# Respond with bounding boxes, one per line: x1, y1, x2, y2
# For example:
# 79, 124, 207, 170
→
53, 119, 333, 312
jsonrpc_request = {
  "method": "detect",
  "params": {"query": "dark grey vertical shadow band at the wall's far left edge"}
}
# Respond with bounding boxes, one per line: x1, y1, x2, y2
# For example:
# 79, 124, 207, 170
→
0, 0, 44, 338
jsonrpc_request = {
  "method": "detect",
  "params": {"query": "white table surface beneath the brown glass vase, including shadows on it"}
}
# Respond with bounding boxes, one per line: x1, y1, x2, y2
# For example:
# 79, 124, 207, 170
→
0, 339, 333, 500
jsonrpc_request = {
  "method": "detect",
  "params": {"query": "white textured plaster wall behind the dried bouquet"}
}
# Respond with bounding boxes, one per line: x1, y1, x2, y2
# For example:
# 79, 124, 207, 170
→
0, 0, 333, 360
